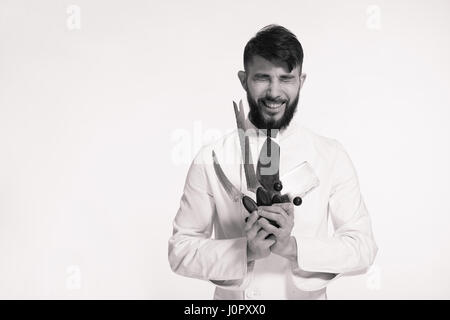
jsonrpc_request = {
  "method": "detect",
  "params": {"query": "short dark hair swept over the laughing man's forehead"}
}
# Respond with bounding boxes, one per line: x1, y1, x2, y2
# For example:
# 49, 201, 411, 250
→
244, 24, 303, 72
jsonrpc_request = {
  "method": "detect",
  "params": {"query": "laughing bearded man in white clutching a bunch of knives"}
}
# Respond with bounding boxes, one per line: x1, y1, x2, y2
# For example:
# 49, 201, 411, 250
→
169, 25, 378, 299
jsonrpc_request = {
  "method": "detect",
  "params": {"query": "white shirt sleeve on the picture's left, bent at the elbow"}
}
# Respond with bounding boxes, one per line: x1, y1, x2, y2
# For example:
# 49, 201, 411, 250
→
169, 147, 248, 289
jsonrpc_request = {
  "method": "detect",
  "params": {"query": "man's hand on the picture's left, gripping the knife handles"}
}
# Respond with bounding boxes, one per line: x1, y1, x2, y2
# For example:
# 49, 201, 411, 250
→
244, 210, 275, 262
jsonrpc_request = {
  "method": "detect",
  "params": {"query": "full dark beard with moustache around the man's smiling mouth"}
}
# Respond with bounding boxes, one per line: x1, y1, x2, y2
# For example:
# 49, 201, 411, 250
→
247, 92, 300, 130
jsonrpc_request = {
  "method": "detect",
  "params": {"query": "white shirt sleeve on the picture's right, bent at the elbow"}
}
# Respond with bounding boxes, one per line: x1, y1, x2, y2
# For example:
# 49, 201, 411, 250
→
292, 141, 378, 290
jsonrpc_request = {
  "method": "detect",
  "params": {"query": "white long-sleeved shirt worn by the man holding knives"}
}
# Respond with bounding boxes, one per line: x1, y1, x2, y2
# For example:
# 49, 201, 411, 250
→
169, 114, 377, 299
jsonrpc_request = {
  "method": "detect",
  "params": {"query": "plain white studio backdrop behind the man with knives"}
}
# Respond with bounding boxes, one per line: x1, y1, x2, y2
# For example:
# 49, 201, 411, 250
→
0, 0, 450, 299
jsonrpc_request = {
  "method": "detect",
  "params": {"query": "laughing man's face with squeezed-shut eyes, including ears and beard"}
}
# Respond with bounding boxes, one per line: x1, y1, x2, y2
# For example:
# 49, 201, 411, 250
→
239, 56, 306, 129
